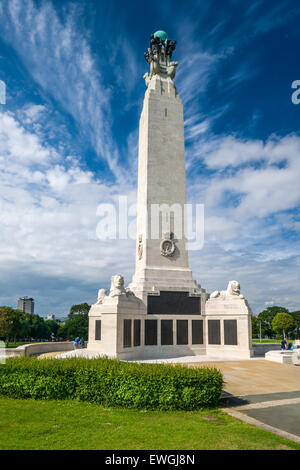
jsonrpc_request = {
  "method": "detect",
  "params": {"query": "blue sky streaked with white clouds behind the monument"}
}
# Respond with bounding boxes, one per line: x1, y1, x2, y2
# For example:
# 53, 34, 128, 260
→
0, 0, 300, 316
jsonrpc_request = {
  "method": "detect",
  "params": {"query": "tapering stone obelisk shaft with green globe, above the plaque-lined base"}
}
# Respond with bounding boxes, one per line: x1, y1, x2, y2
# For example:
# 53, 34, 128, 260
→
130, 31, 205, 303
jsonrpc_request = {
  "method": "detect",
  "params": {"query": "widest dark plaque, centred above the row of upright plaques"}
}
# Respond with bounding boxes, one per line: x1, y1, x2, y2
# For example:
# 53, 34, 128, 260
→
147, 291, 201, 315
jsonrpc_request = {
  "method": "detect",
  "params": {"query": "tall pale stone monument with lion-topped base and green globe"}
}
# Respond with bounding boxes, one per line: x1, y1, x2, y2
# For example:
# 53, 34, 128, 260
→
88, 31, 252, 359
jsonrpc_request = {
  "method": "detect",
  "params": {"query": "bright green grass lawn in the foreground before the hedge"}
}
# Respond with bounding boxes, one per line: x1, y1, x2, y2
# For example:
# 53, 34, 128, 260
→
0, 398, 300, 450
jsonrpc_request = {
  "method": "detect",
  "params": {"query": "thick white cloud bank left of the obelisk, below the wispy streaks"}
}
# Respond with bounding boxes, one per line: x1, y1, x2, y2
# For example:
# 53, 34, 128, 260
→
0, 109, 135, 298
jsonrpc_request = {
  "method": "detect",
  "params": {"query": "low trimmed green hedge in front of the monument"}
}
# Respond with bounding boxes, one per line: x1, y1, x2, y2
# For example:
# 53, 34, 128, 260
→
0, 357, 223, 410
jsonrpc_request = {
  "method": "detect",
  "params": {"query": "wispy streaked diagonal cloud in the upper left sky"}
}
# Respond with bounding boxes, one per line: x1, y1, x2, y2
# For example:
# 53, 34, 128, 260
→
0, 0, 130, 182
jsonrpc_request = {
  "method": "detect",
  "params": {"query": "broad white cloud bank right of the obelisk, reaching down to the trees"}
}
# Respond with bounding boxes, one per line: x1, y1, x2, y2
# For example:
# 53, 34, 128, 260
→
183, 132, 300, 313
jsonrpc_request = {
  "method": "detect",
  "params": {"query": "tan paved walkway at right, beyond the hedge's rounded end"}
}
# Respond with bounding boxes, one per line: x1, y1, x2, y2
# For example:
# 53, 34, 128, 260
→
189, 360, 300, 443
